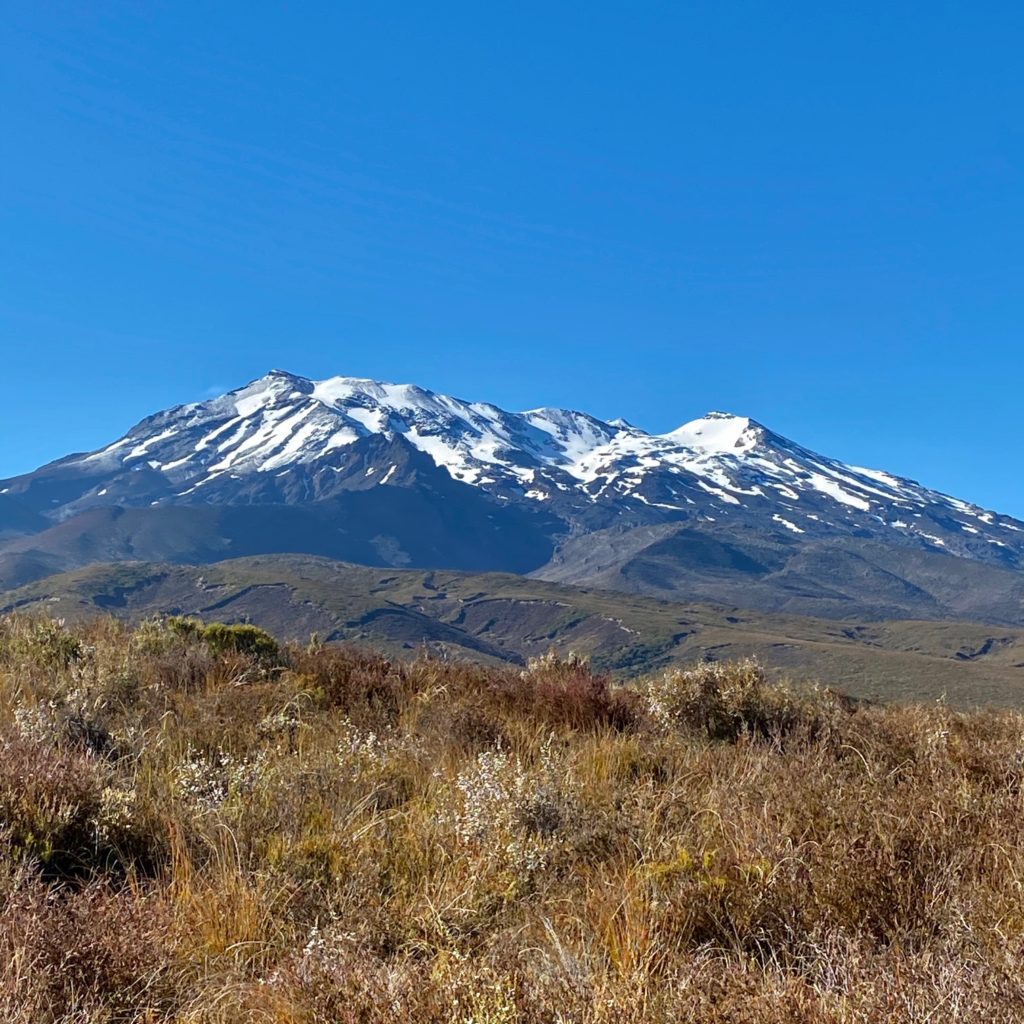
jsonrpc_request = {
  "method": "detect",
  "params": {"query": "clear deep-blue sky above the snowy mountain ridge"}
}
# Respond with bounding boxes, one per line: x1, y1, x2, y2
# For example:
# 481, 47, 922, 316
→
6, 0, 1024, 516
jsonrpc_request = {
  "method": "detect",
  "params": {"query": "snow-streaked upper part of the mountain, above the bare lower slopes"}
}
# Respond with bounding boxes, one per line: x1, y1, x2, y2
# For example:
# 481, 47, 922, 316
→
6, 371, 1024, 564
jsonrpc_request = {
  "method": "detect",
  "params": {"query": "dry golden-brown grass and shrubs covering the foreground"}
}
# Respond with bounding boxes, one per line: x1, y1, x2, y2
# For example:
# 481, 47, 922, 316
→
0, 616, 1024, 1024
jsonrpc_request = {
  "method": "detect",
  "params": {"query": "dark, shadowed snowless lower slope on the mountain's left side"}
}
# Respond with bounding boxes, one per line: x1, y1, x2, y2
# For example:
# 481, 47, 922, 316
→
0, 478, 559, 588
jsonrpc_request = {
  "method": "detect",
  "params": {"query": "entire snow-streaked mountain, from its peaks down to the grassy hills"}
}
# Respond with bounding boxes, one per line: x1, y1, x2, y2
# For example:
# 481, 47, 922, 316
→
0, 371, 1024, 624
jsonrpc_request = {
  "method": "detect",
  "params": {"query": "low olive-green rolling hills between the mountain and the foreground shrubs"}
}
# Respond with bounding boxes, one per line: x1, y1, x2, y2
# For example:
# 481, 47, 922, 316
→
0, 555, 1024, 707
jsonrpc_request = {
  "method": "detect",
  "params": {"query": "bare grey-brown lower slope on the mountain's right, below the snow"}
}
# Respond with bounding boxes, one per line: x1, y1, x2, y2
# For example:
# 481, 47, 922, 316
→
532, 523, 1024, 625
